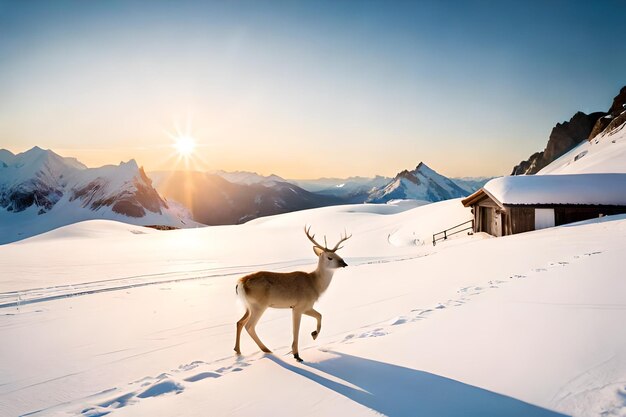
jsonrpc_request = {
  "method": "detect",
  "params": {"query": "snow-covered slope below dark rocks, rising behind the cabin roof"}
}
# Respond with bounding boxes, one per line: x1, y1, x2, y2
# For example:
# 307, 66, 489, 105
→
538, 118, 626, 175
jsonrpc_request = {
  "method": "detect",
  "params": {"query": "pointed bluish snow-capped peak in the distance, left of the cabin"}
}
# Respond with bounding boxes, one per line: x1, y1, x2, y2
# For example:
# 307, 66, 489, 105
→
367, 162, 469, 203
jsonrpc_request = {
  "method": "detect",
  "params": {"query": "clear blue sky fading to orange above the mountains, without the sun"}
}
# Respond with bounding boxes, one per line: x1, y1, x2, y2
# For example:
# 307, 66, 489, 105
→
0, 0, 626, 179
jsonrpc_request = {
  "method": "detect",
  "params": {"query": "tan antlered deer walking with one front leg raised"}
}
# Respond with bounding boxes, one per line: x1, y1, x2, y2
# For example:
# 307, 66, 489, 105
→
235, 225, 352, 362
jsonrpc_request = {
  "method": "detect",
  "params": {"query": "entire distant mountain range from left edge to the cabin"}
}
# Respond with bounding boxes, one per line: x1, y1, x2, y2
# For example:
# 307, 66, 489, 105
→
0, 147, 488, 243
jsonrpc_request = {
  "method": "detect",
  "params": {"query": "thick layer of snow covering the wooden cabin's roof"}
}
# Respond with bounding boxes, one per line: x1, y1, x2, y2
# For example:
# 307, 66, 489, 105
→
484, 174, 626, 205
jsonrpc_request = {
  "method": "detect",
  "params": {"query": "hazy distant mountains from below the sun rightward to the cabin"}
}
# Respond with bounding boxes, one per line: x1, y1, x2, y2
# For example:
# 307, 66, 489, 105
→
149, 163, 488, 225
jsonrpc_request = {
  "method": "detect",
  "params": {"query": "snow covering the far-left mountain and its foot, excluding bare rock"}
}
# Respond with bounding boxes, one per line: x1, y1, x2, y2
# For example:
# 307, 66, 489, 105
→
0, 147, 195, 244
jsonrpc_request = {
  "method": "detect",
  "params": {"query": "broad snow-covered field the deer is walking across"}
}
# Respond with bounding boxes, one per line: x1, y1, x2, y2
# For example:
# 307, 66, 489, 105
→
0, 199, 626, 417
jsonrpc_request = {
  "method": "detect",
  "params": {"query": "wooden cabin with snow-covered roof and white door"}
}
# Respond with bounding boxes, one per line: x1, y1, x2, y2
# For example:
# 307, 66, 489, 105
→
462, 174, 626, 236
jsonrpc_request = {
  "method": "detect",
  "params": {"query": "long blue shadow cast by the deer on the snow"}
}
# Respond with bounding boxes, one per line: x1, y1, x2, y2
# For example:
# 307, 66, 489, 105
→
267, 352, 564, 417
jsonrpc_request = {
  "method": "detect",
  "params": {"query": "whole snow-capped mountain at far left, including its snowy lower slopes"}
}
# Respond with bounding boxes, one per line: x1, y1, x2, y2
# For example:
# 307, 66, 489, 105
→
0, 147, 194, 243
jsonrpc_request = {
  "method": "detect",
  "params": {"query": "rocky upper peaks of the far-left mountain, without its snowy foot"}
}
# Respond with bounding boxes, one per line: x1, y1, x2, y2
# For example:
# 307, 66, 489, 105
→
0, 146, 168, 217
